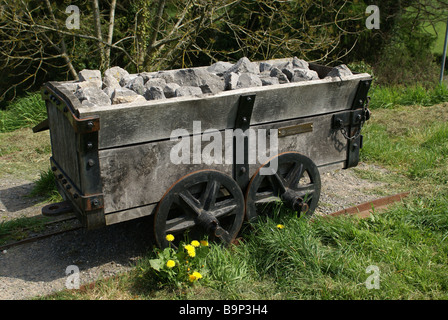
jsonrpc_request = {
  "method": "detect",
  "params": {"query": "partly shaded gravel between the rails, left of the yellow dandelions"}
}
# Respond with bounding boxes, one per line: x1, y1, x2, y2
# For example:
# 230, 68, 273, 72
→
0, 217, 153, 289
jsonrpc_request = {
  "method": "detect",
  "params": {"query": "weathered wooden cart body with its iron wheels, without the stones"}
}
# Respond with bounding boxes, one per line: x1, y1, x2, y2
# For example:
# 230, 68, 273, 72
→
35, 59, 371, 247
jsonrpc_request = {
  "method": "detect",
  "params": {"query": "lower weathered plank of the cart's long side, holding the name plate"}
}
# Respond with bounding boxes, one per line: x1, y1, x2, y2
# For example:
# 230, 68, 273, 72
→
99, 114, 347, 213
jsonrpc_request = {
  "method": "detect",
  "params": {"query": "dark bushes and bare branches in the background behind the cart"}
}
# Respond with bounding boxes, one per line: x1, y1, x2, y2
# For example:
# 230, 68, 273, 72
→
0, 0, 448, 107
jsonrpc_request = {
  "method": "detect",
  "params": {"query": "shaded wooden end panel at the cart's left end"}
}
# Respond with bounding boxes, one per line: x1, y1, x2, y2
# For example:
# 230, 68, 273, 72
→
46, 101, 81, 187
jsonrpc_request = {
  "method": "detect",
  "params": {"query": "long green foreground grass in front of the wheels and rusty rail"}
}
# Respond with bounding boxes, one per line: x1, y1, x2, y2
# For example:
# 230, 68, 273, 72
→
45, 198, 448, 300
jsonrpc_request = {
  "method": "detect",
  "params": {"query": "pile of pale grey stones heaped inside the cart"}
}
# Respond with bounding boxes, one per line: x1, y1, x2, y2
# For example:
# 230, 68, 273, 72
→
71, 57, 352, 106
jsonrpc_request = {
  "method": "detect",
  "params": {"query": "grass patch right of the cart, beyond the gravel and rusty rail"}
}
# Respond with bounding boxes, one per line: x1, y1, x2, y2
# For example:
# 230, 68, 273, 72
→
362, 104, 448, 194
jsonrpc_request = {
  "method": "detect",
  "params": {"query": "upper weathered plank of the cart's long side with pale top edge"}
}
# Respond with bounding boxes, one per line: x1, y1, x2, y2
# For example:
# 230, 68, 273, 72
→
78, 74, 370, 149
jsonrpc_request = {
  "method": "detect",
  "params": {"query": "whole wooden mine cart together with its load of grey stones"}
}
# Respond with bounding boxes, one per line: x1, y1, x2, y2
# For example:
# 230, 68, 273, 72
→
34, 58, 372, 247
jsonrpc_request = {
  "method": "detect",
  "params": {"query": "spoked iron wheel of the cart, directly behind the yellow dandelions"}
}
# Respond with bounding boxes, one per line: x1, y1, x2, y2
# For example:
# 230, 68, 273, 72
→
154, 170, 244, 248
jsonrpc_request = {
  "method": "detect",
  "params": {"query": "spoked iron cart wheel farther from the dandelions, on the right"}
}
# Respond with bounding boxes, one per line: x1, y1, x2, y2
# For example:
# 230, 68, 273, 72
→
246, 152, 321, 222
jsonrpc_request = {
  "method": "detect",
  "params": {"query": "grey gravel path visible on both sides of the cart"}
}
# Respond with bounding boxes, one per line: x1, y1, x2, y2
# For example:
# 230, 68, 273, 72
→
0, 164, 392, 300
